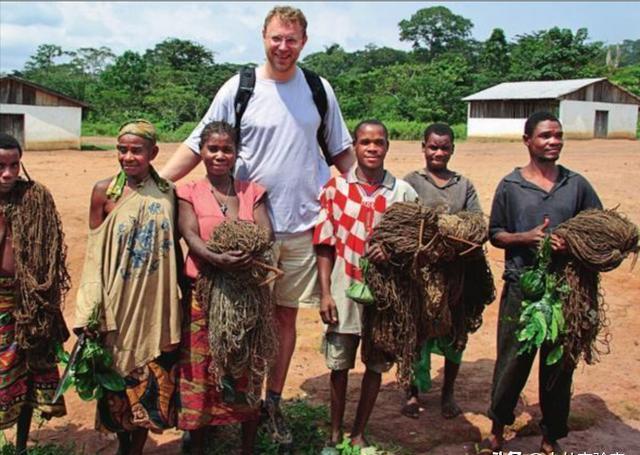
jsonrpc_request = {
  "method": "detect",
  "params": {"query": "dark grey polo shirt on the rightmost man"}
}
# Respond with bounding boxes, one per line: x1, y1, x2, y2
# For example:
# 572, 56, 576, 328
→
489, 166, 602, 281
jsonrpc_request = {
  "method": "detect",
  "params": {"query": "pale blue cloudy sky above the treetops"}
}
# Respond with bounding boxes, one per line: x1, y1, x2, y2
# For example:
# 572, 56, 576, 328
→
0, 0, 640, 72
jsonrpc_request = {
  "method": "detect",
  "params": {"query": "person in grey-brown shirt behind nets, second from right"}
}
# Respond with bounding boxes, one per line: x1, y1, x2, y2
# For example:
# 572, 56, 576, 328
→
402, 123, 482, 418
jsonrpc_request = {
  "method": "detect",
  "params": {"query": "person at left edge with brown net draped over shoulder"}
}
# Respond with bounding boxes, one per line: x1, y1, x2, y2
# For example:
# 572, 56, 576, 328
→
0, 133, 70, 454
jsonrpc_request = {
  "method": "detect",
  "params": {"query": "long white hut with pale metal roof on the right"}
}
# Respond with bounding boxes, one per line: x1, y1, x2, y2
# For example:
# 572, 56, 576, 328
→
463, 78, 640, 139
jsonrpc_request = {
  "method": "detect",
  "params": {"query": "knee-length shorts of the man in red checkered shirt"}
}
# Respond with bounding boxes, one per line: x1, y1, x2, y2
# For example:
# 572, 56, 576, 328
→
322, 332, 393, 373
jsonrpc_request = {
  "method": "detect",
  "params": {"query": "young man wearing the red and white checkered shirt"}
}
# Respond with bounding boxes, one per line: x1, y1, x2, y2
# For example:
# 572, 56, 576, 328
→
313, 120, 417, 447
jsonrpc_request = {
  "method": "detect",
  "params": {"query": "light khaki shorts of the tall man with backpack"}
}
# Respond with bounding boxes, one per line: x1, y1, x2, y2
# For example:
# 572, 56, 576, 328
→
273, 230, 320, 308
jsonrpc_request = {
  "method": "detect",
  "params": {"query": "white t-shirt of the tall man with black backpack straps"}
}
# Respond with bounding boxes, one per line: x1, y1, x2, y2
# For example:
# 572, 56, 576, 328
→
185, 68, 351, 237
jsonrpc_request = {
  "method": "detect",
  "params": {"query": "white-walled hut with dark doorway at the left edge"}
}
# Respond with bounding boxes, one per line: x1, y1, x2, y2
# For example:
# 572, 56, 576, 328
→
0, 76, 88, 150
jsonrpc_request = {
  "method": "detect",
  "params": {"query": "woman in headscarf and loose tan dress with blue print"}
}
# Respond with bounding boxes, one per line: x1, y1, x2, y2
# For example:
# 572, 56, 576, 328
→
75, 120, 181, 454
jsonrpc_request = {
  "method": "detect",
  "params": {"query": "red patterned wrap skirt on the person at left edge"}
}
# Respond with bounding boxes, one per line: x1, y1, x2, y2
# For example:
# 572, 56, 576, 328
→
0, 277, 67, 430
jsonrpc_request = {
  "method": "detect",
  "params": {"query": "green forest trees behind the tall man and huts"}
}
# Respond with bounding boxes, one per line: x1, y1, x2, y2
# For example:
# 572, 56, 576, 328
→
11, 6, 640, 135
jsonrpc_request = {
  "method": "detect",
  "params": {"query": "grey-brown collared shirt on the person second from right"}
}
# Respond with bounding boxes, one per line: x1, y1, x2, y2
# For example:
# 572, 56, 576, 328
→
403, 169, 482, 213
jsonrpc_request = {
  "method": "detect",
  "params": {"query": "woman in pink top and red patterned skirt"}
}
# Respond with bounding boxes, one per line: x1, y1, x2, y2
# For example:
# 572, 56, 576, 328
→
178, 122, 271, 455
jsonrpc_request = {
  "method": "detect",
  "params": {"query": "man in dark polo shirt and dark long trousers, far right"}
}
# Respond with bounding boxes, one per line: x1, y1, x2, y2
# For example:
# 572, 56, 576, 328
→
481, 112, 602, 454
